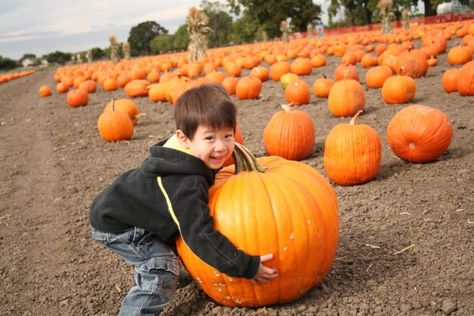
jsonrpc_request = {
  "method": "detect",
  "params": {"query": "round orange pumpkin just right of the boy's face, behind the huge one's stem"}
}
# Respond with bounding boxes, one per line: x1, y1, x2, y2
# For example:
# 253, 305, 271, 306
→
263, 105, 315, 160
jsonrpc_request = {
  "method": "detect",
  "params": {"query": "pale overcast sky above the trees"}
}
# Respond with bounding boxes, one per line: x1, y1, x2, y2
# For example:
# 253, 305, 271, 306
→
0, 0, 329, 59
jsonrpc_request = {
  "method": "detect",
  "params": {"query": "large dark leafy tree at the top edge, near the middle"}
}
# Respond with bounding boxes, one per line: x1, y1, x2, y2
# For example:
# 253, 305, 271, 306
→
227, 0, 321, 38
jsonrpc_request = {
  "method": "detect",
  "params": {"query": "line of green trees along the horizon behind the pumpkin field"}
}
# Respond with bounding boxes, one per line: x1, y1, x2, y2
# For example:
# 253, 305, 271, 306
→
0, 0, 472, 69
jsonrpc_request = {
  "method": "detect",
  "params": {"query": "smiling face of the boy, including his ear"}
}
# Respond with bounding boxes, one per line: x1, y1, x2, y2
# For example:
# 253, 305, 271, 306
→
176, 125, 234, 169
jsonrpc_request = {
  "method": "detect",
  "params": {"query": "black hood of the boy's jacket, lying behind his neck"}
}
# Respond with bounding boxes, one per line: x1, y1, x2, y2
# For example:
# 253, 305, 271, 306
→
141, 143, 214, 184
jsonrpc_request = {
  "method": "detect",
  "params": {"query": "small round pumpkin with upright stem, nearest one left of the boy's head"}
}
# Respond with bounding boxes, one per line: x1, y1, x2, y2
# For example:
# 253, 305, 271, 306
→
97, 100, 133, 142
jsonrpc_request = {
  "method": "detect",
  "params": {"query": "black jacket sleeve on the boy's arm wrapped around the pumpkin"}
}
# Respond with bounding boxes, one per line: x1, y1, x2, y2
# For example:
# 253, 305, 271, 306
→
162, 177, 260, 279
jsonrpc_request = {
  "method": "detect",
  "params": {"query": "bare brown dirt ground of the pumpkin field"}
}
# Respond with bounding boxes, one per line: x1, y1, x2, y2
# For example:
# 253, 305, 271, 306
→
0, 36, 474, 315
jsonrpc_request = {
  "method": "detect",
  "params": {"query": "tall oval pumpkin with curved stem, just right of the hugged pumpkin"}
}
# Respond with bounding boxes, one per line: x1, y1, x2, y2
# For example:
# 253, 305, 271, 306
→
324, 111, 382, 185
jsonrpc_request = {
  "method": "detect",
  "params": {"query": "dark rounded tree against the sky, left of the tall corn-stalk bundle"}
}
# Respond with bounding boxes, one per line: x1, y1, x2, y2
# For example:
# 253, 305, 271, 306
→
128, 21, 168, 56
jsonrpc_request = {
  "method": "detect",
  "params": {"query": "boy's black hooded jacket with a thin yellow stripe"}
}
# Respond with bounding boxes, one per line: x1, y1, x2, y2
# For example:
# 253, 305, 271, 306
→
89, 144, 260, 278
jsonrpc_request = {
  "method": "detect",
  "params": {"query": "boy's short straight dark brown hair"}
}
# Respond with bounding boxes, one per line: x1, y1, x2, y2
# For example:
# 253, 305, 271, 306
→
174, 84, 237, 139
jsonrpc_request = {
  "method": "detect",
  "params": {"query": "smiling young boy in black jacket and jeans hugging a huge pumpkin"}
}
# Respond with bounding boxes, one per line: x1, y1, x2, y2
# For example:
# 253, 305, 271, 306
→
89, 85, 278, 315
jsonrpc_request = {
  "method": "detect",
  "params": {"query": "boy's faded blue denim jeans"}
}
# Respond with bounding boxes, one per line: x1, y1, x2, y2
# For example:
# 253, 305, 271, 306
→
91, 227, 187, 316
